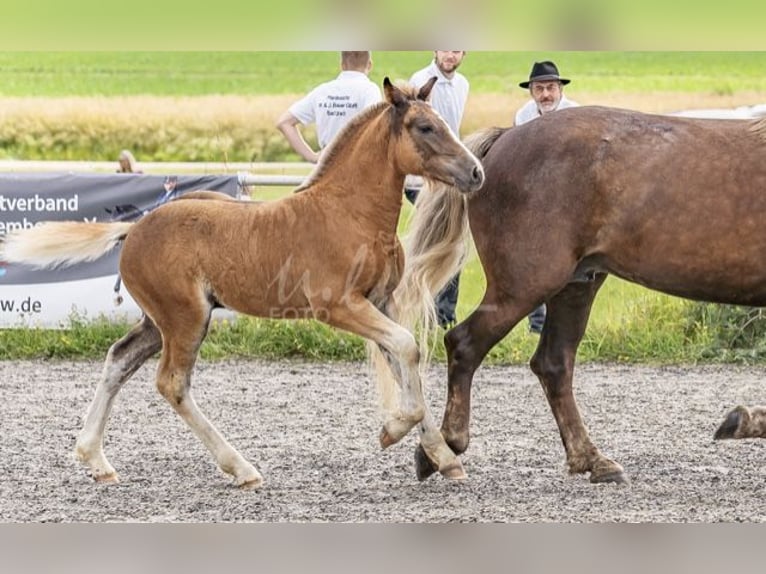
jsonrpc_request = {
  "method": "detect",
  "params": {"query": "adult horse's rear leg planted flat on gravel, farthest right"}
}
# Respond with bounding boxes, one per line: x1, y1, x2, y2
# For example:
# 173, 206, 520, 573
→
530, 274, 627, 482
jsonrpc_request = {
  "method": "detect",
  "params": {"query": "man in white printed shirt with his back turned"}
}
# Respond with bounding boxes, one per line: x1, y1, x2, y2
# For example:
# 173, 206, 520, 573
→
277, 51, 382, 163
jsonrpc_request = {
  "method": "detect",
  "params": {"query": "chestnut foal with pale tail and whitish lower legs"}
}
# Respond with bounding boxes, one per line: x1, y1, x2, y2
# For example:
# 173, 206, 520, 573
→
3, 78, 484, 488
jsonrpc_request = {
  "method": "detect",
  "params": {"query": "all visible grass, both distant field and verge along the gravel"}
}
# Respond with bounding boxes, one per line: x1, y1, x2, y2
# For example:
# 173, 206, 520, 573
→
0, 52, 766, 363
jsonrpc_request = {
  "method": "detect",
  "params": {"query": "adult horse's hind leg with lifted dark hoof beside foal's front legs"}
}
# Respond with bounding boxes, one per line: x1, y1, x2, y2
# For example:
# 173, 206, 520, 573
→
415, 290, 535, 480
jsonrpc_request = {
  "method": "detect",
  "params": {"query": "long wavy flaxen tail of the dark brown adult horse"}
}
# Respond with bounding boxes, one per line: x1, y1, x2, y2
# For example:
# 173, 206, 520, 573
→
369, 127, 508, 414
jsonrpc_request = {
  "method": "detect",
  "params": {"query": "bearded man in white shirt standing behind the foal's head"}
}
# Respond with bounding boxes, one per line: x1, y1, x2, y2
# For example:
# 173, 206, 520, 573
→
404, 50, 469, 328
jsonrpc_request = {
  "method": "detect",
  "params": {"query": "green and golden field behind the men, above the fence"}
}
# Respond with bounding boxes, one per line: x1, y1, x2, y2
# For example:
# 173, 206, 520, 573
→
0, 52, 766, 163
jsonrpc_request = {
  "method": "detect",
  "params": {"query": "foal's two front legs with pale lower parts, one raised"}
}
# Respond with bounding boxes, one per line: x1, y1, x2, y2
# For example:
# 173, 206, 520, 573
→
325, 296, 465, 479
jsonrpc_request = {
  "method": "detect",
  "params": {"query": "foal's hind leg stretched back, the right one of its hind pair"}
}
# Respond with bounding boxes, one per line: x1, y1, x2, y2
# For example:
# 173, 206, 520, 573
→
152, 310, 263, 489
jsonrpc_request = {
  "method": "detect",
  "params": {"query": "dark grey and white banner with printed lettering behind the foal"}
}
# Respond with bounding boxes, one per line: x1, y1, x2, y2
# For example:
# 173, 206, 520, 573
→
0, 173, 239, 328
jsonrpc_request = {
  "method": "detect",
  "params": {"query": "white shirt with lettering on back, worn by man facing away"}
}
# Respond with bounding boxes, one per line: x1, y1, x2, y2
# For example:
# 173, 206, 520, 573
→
290, 71, 382, 148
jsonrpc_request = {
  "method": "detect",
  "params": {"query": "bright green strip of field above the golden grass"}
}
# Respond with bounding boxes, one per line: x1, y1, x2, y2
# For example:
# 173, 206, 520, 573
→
0, 51, 766, 97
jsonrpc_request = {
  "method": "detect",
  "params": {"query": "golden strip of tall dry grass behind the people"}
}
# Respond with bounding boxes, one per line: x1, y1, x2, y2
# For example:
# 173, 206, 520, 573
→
0, 89, 764, 162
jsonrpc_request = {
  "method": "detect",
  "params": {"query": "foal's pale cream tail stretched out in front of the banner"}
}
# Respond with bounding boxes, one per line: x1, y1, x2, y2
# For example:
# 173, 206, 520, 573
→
0, 221, 133, 268
